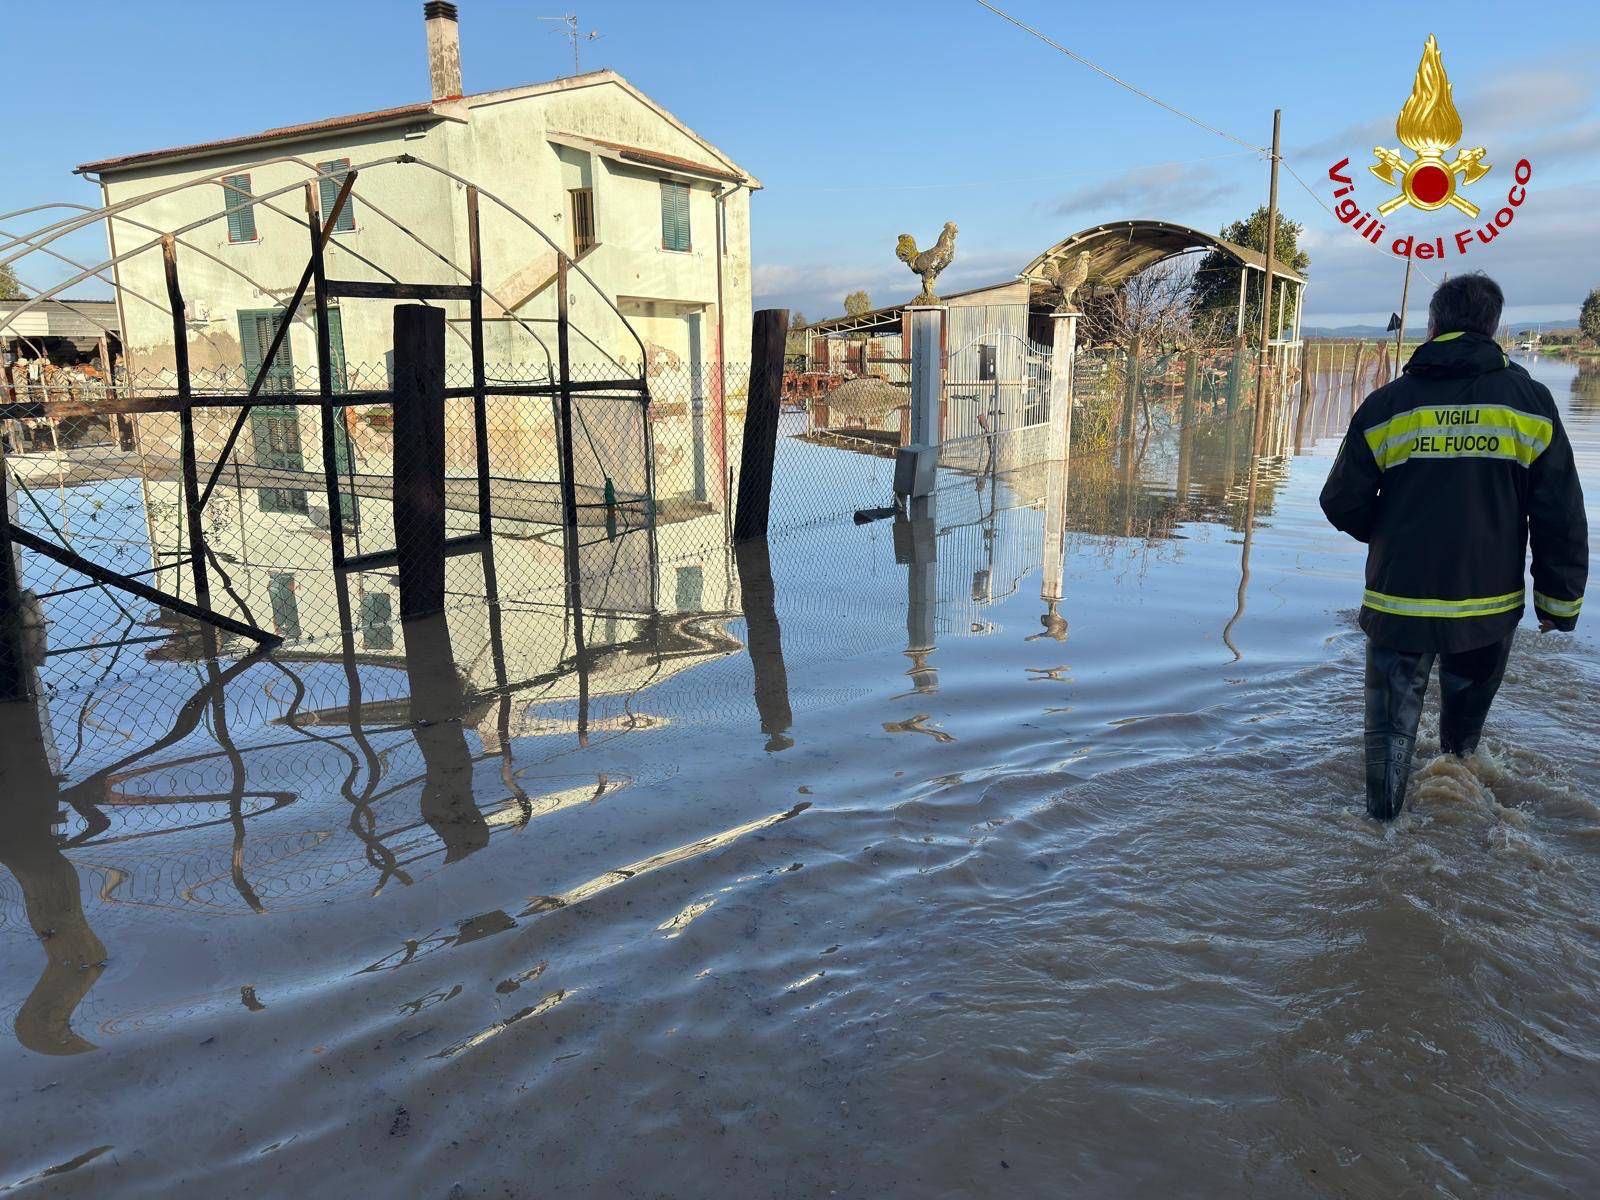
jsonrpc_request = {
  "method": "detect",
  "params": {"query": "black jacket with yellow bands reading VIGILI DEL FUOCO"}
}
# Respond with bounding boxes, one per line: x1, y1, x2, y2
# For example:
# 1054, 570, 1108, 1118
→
1322, 333, 1589, 651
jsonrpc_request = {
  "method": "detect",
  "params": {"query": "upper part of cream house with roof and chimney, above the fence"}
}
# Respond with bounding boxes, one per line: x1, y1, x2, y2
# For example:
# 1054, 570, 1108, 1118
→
77, 0, 760, 387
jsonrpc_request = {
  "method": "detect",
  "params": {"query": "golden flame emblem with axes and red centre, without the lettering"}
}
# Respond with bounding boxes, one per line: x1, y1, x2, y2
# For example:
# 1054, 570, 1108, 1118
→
1366, 34, 1490, 216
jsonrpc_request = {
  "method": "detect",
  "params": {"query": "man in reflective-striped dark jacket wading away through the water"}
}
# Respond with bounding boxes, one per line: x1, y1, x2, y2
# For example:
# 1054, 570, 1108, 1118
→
1322, 274, 1589, 821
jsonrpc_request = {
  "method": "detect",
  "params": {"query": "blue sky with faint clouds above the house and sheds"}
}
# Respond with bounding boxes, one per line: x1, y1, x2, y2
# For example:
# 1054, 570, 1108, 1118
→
0, 0, 1600, 323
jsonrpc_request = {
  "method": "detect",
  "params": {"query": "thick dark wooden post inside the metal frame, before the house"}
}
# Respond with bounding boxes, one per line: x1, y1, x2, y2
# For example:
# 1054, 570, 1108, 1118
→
395, 304, 445, 619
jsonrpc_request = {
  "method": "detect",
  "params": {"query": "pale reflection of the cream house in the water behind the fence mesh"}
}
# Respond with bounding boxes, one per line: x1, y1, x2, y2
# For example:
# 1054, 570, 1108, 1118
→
144, 464, 738, 696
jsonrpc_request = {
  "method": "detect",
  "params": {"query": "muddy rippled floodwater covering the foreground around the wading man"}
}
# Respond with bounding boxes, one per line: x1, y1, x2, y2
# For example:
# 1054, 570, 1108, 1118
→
0, 352, 1600, 1198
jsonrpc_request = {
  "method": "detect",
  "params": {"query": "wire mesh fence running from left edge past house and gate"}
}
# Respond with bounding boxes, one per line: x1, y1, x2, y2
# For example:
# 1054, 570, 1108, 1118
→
3, 331, 1298, 704
